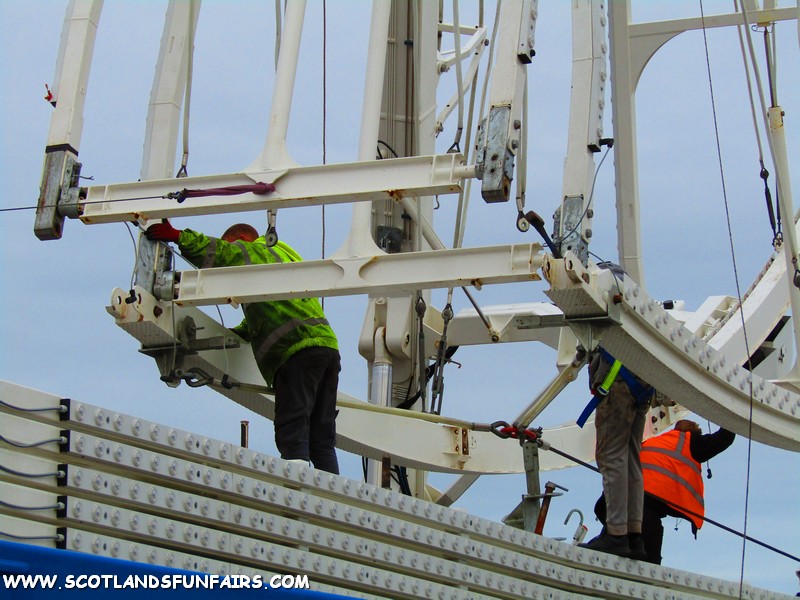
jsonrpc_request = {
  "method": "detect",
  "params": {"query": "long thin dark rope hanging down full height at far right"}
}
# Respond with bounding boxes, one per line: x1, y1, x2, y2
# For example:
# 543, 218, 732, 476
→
700, 0, 753, 599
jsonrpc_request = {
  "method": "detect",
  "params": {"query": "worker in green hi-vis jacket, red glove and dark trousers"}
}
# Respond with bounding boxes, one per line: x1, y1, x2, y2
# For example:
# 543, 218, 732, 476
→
145, 221, 341, 474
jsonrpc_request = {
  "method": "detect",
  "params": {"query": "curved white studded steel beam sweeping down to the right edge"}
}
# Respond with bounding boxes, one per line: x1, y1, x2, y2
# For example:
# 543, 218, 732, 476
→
544, 255, 800, 451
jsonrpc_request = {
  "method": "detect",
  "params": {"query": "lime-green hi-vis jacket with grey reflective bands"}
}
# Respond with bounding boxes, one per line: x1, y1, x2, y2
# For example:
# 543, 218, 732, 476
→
178, 229, 339, 385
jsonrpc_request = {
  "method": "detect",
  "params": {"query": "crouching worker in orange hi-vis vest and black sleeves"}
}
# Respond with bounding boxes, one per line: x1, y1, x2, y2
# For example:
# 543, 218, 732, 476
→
595, 419, 735, 565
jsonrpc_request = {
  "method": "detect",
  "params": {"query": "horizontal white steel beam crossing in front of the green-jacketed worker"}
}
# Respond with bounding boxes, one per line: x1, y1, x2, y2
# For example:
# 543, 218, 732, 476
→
175, 244, 542, 306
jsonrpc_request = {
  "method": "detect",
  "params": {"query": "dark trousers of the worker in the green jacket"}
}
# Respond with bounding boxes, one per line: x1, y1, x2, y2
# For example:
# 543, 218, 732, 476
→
274, 347, 341, 474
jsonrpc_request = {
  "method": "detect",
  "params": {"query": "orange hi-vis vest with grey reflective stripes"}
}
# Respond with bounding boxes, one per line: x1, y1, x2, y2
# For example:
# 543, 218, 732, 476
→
640, 430, 705, 529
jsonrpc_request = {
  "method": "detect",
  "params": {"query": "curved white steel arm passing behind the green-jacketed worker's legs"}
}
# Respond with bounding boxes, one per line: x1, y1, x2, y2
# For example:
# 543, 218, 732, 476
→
107, 286, 568, 473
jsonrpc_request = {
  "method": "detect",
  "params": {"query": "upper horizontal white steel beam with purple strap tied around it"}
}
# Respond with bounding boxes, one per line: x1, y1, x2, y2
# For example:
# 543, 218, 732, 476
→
78, 154, 474, 224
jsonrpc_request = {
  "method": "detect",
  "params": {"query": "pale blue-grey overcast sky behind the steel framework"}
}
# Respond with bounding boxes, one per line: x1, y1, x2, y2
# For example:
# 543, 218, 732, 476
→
0, 0, 800, 593
